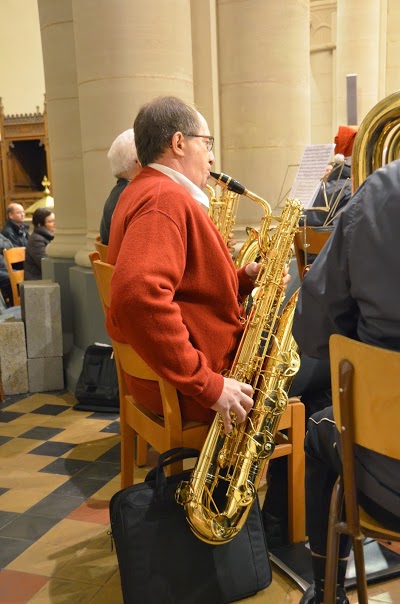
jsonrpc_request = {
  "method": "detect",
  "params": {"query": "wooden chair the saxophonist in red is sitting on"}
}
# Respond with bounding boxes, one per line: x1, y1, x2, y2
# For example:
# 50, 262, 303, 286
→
90, 252, 305, 543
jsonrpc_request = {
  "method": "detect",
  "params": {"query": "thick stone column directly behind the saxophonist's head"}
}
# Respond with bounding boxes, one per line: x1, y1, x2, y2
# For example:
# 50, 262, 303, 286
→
72, 0, 193, 266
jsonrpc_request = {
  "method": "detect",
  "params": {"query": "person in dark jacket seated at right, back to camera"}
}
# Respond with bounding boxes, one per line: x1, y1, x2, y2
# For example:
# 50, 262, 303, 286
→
293, 160, 400, 604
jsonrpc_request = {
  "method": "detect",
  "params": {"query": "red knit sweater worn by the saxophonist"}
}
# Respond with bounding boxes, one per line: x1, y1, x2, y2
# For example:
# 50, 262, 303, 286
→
107, 168, 253, 421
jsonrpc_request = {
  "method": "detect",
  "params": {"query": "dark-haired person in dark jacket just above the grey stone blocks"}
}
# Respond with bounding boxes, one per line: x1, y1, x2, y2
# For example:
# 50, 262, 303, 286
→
24, 208, 55, 281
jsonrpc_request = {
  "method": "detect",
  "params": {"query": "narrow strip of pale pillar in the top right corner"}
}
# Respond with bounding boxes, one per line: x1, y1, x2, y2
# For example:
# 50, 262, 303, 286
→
385, 0, 400, 96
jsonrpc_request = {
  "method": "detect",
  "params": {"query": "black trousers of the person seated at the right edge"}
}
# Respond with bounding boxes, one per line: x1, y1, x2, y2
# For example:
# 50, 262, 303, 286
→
305, 407, 400, 558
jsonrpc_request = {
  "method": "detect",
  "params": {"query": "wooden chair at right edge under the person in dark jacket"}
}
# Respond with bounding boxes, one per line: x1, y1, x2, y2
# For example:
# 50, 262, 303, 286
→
324, 335, 400, 604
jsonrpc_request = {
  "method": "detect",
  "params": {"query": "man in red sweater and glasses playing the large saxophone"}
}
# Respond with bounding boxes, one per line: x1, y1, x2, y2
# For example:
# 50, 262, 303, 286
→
107, 97, 258, 432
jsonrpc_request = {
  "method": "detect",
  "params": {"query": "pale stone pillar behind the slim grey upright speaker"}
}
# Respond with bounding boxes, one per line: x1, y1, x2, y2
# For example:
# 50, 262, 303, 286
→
336, 0, 386, 125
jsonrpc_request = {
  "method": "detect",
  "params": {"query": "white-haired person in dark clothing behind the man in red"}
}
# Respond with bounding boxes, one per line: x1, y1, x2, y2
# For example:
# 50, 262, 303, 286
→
100, 128, 141, 245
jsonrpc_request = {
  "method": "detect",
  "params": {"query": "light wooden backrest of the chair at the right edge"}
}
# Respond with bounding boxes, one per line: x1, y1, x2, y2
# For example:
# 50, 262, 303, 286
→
329, 334, 400, 459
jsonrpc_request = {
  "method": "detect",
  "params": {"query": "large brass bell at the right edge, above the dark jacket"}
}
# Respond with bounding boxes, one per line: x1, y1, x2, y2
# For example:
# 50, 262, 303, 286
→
351, 91, 400, 191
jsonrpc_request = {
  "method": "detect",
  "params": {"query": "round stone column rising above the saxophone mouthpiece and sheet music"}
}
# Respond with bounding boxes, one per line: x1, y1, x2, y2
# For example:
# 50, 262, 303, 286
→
217, 0, 310, 239
